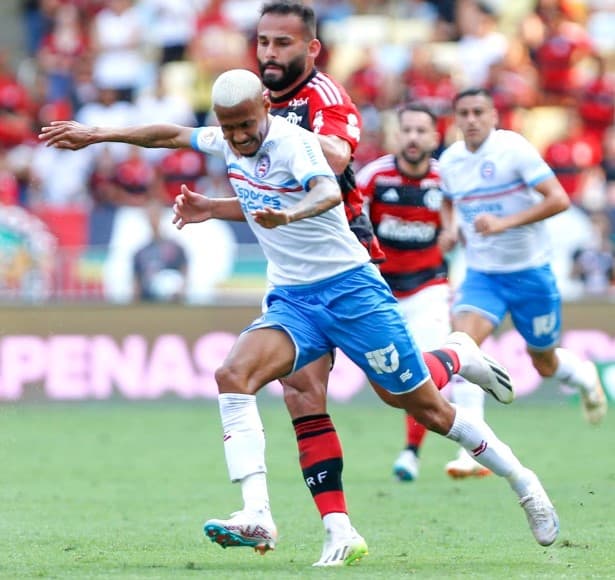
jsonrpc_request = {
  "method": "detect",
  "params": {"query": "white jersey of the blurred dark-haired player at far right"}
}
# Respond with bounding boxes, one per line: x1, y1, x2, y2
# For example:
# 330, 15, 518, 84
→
440, 130, 553, 272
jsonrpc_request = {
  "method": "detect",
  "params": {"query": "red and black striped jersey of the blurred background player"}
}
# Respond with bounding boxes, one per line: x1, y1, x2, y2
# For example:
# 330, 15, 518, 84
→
357, 154, 447, 296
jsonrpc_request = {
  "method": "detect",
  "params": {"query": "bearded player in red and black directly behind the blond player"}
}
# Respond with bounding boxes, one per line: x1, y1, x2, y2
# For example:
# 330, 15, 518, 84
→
256, 1, 384, 562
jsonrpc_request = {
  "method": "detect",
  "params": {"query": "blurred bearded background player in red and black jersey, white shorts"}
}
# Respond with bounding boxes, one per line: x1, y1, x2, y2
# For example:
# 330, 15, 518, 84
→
357, 103, 490, 481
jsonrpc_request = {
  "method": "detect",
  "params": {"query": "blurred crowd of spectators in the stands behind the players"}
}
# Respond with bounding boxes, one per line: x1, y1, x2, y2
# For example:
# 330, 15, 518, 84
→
0, 0, 615, 302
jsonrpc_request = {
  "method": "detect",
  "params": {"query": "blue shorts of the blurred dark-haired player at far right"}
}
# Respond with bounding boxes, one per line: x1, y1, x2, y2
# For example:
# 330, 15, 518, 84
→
452, 266, 562, 351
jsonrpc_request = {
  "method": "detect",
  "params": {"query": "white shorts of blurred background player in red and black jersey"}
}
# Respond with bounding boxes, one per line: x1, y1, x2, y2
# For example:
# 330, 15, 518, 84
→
398, 284, 451, 351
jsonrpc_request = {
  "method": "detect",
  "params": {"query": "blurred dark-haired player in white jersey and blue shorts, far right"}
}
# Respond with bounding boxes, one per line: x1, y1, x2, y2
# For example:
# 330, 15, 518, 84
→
440, 89, 607, 424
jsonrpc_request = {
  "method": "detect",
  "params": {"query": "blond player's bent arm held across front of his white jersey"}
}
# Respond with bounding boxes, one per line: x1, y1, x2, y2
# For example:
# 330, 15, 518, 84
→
252, 176, 342, 229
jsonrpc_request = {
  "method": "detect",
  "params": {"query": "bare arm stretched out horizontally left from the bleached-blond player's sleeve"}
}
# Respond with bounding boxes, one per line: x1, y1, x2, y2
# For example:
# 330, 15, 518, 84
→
38, 121, 194, 151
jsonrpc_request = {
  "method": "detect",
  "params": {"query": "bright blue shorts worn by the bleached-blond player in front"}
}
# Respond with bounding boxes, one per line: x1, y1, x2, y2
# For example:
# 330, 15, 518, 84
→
244, 264, 429, 394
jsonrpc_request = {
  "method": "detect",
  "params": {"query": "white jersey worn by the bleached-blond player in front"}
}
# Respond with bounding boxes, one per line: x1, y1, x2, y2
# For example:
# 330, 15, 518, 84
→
192, 117, 369, 286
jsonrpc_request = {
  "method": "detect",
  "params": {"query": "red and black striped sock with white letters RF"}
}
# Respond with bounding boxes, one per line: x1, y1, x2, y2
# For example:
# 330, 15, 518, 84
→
293, 415, 348, 517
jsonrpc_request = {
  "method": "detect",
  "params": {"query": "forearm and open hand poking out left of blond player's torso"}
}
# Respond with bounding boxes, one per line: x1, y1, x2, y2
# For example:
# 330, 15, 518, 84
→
173, 184, 245, 230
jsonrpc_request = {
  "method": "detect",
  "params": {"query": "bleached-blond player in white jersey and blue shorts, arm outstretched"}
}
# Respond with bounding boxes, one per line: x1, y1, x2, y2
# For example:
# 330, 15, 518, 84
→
40, 70, 559, 566
